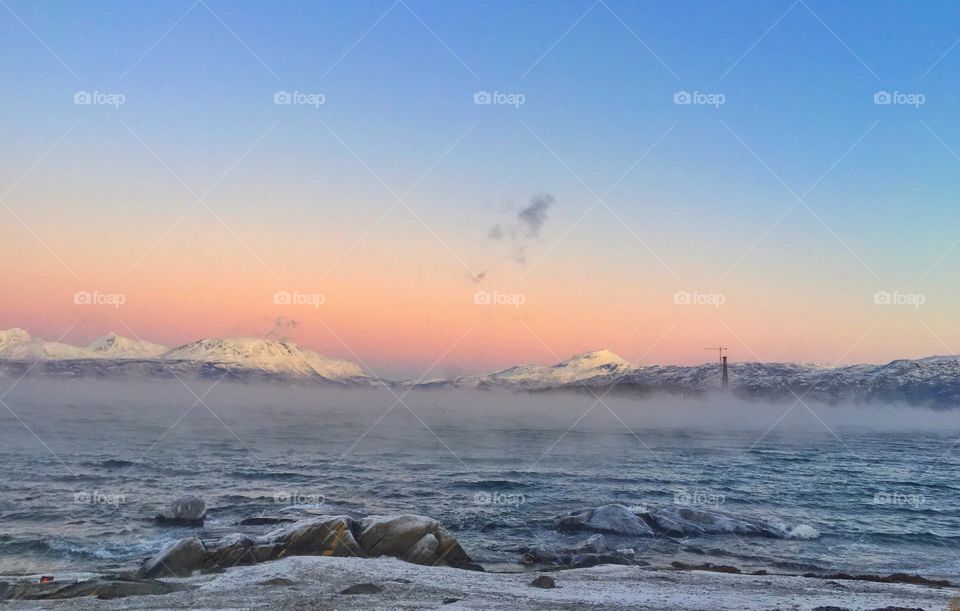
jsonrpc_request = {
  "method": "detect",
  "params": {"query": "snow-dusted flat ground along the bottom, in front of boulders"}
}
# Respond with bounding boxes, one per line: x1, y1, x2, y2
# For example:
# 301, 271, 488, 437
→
11, 556, 960, 610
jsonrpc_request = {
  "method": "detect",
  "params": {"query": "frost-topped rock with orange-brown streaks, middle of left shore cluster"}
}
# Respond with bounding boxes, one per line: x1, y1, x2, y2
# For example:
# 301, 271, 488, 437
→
253, 516, 363, 562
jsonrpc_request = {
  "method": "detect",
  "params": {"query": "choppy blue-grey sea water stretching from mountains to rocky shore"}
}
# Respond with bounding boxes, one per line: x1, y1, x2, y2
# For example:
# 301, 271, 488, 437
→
0, 381, 960, 579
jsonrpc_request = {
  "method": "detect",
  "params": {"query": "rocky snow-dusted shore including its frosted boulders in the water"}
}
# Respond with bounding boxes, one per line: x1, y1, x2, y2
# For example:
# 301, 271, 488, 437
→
0, 497, 960, 609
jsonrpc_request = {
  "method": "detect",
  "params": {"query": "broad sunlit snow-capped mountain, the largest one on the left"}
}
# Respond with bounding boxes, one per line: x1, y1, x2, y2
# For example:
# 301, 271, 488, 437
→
160, 337, 367, 381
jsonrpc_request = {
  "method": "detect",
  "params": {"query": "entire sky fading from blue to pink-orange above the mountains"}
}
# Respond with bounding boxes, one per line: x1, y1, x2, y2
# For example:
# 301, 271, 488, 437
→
0, 0, 960, 377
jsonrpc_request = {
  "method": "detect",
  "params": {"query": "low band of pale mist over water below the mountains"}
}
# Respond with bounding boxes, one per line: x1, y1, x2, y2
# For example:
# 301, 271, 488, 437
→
7, 379, 960, 436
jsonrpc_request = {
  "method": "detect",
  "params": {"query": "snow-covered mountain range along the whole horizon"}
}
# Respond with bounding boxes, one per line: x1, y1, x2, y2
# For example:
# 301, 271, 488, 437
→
0, 329, 960, 408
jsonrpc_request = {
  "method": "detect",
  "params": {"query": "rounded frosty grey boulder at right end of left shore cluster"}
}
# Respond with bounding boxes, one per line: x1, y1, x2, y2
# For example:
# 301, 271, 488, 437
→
357, 515, 476, 568
